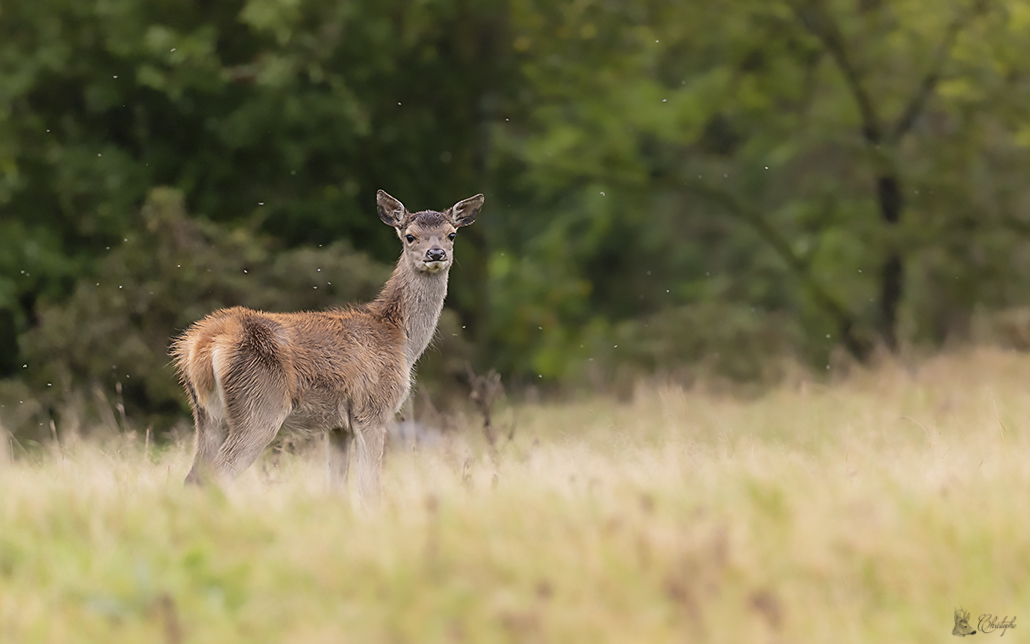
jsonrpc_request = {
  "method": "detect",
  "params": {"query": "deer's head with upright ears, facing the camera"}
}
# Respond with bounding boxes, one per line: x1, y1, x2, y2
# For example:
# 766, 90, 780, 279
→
376, 191, 483, 274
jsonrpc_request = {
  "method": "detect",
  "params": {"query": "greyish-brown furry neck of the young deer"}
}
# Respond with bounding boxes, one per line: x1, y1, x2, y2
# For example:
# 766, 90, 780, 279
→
374, 258, 449, 369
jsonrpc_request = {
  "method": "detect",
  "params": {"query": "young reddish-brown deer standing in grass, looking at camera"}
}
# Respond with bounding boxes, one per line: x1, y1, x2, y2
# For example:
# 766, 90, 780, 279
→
171, 191, 483, 503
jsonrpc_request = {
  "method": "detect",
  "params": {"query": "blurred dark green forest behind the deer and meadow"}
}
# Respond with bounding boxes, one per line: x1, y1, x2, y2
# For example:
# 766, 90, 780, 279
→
0, 0, 1030, 436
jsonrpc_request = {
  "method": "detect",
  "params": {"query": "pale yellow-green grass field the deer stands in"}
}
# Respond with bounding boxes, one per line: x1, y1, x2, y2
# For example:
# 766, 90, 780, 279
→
0, 350, 1030, 643
